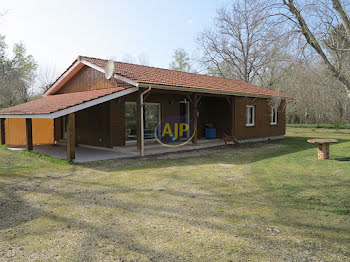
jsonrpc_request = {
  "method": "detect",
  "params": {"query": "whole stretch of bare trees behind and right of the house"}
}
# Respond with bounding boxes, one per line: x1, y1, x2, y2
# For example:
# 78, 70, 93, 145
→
170, 0, 350, 123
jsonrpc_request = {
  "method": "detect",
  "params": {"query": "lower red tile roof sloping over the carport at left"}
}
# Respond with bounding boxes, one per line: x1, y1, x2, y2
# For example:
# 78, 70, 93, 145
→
0, 87, 126, 115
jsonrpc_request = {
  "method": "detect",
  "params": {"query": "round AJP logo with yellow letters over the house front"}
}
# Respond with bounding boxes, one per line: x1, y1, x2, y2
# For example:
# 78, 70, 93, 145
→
154, 116, 196, 147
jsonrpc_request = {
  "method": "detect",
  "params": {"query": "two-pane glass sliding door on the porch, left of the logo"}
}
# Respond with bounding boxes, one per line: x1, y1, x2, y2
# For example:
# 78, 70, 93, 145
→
125, 102, 160, 141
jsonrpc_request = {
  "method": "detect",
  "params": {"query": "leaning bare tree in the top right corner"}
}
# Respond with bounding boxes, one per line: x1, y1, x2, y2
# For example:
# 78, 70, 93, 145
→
282, 0, 350, 92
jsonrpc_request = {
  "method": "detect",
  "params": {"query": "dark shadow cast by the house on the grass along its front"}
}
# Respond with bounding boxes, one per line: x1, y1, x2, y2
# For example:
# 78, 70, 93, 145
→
80, 136, 350, 172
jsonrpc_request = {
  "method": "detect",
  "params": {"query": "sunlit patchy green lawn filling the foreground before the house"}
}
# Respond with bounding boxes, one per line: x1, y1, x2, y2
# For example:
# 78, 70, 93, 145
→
0, 128, 350, 261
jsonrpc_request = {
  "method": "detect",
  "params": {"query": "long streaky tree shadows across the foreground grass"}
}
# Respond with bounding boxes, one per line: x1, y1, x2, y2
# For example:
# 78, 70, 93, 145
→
0, 167, 350, 261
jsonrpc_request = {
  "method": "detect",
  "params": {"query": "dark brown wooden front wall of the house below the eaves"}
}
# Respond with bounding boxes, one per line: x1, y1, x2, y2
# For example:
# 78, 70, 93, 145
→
55, 84, 285, 147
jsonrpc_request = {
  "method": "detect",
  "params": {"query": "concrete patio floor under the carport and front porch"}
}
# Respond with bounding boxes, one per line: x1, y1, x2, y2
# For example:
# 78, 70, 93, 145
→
10, 139, 228, 163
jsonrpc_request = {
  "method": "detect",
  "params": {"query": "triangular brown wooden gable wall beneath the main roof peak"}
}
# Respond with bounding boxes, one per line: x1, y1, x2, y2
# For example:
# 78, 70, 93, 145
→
57, 66, 117, 94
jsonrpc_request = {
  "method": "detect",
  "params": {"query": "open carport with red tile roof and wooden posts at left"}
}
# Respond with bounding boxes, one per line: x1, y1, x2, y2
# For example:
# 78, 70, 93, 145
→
0, 87, 138, 160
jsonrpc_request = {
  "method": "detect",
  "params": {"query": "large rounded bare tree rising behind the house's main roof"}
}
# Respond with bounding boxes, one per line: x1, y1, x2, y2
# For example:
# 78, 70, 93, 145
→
197, 0, 288, 85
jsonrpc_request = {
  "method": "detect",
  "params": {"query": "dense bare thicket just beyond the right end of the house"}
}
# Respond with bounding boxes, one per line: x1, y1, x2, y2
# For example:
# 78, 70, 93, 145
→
277, 54, 350, 123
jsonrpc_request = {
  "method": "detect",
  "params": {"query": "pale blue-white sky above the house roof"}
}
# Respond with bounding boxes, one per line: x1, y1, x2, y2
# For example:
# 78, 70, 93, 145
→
0, 0, 225, 73
